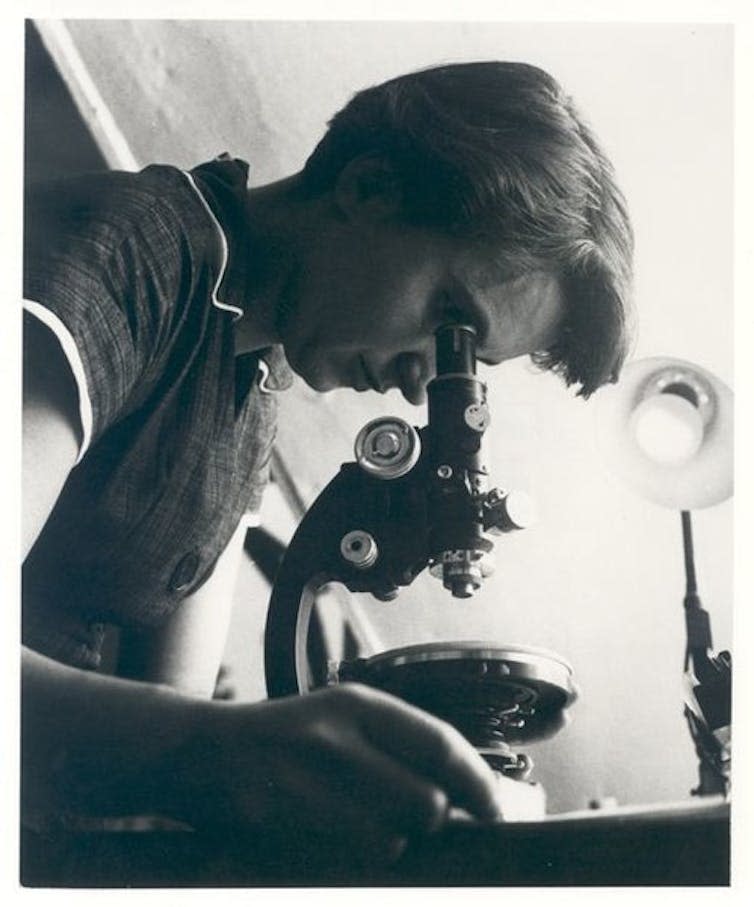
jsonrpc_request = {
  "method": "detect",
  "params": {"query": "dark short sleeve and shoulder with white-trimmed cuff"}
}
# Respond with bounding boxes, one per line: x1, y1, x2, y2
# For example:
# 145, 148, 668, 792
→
24, 165, 226, 449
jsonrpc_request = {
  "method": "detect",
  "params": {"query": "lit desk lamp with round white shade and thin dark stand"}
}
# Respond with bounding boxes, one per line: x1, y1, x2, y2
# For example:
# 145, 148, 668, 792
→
596, 357, 733, 794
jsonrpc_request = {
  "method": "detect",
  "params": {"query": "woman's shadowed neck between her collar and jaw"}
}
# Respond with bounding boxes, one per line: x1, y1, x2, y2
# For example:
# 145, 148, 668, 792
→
236, 175, 309, 352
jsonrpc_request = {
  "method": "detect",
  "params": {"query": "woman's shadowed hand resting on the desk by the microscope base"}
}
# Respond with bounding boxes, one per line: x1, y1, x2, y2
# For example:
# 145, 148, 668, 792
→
178, 684, 501, 860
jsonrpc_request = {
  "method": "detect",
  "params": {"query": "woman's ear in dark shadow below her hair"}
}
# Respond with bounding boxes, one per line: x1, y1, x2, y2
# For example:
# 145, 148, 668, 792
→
334, 154, 403, 223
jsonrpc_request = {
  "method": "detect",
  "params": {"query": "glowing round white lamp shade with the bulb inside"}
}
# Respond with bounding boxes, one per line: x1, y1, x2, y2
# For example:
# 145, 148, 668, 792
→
596, 357, 733, 510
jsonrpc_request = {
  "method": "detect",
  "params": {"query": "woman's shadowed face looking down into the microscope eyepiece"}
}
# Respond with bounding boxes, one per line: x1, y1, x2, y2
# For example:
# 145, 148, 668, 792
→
274, 223, 563, 403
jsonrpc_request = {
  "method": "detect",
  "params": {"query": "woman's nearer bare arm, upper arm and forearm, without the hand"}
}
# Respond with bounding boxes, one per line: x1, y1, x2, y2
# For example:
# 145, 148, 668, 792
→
21, 319, 206, 821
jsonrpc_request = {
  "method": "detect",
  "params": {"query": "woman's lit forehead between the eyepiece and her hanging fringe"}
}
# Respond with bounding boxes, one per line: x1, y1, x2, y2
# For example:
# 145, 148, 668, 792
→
440, 246, 565, 364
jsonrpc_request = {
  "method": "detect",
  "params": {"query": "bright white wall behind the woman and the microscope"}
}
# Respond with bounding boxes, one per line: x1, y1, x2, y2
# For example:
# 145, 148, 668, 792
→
57, 21, 733, 811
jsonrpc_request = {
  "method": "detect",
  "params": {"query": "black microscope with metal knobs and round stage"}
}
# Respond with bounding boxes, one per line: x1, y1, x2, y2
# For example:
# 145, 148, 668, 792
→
265, 324, 576, 800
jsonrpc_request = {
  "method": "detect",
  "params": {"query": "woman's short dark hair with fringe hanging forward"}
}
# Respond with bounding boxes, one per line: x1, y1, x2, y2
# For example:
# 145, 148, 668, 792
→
302, 61, 633, 397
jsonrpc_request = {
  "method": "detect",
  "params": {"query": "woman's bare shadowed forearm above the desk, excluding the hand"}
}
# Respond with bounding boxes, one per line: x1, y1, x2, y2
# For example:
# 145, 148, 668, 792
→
21, 648, 206, 827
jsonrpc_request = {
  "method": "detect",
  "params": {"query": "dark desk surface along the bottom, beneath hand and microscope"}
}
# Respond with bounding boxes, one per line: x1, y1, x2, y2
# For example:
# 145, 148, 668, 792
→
21, 799, 730, 888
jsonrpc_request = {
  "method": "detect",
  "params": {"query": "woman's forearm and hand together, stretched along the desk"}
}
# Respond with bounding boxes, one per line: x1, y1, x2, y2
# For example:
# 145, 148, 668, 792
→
21, 650, 506, 858
